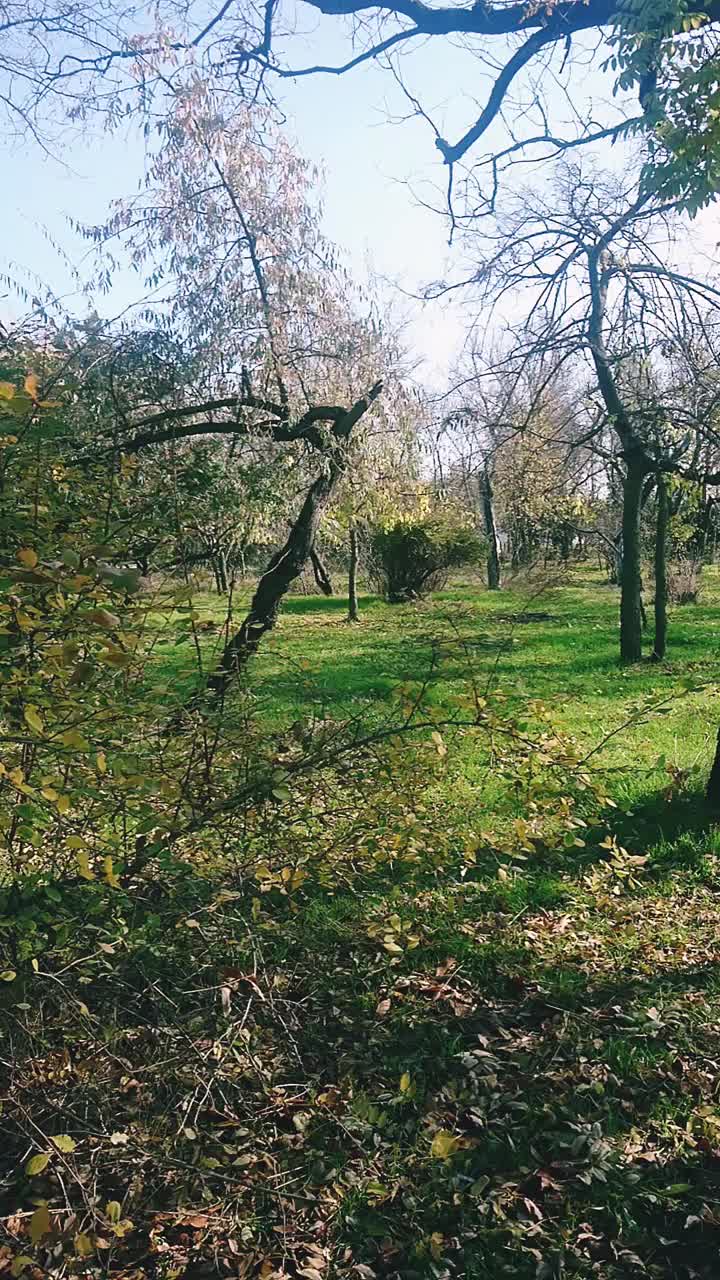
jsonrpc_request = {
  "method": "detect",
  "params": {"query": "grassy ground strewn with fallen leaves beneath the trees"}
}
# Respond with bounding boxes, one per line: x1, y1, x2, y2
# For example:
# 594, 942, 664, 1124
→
0, 571, 720, 1280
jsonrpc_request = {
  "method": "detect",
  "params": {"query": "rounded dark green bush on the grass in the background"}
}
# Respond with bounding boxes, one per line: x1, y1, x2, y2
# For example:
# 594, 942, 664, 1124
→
369, 516, 483, 604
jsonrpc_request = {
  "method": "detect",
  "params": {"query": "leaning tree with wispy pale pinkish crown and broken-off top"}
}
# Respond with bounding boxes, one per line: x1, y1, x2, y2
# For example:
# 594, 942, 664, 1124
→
81, 83, 400, 698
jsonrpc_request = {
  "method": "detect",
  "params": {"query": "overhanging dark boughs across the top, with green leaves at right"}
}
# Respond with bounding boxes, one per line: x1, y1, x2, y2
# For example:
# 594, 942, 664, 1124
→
0, 0, 720, 211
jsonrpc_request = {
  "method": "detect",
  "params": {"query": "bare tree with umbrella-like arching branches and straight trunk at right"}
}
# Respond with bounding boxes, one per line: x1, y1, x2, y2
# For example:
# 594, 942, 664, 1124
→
445, 164, 720, 662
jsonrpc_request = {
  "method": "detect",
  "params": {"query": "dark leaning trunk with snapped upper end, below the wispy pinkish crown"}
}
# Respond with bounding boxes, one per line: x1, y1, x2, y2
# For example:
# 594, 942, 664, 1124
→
190, 383, 382, 708
